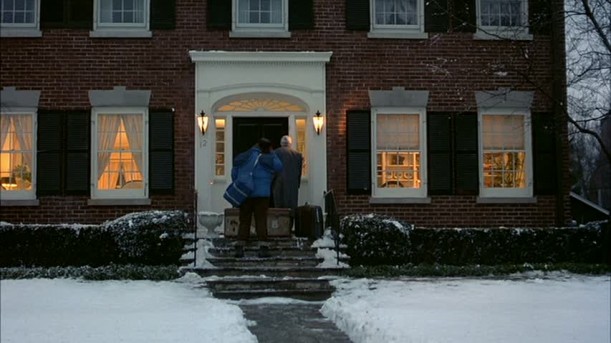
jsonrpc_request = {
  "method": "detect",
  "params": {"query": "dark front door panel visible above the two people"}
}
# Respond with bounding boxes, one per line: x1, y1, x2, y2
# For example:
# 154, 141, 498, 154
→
232, 117, 289, 158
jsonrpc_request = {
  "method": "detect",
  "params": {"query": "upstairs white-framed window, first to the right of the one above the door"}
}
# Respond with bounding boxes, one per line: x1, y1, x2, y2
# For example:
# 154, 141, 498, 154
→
369, 0, 427, 38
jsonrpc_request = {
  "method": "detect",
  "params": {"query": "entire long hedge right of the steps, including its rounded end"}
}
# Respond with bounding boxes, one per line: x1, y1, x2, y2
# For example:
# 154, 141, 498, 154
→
340, 214, 611, 266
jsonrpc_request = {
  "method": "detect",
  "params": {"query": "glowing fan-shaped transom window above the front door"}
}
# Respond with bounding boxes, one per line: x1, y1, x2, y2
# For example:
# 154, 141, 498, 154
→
217, 96, 306, 112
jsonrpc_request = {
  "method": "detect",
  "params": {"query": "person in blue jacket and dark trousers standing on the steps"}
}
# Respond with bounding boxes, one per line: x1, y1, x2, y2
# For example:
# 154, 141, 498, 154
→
231, 138, 282, 257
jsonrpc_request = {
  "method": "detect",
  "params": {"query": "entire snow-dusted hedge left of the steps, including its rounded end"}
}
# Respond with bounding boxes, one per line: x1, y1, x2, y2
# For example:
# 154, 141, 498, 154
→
0, 211, 191, 267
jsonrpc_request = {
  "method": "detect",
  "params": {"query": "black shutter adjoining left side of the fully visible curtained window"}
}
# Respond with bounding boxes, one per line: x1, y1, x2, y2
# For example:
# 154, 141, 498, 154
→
65, 112, 91, 195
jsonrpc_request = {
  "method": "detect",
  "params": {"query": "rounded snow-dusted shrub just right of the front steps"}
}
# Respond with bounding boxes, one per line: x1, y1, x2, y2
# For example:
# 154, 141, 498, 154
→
340, 214, 413, 265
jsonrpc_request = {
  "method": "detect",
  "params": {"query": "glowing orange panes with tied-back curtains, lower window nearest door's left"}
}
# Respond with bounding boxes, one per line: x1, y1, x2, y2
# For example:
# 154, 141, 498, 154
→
97, 114, 144, 190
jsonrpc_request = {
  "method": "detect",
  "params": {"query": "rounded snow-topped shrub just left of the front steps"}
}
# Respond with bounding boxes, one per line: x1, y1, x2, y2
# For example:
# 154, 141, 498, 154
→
101, 211, 189, 265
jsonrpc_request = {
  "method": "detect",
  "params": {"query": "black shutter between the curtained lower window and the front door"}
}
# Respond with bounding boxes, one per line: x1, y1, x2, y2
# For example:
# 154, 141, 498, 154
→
149, 110, 174, 194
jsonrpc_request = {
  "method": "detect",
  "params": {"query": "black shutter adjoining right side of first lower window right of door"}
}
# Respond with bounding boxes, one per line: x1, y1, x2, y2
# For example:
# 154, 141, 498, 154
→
426, 112, 452, 195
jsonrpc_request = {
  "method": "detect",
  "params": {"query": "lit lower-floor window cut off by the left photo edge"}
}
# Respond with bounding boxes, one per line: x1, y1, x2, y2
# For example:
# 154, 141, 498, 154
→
0, 112, 36, 200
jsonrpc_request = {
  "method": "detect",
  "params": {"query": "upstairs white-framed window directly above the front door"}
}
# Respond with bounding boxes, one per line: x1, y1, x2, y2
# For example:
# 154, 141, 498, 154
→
231, 0, 290, 37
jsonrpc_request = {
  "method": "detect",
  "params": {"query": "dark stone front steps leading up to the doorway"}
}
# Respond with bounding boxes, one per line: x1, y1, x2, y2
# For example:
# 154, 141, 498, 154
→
181, 237, 342, 301
